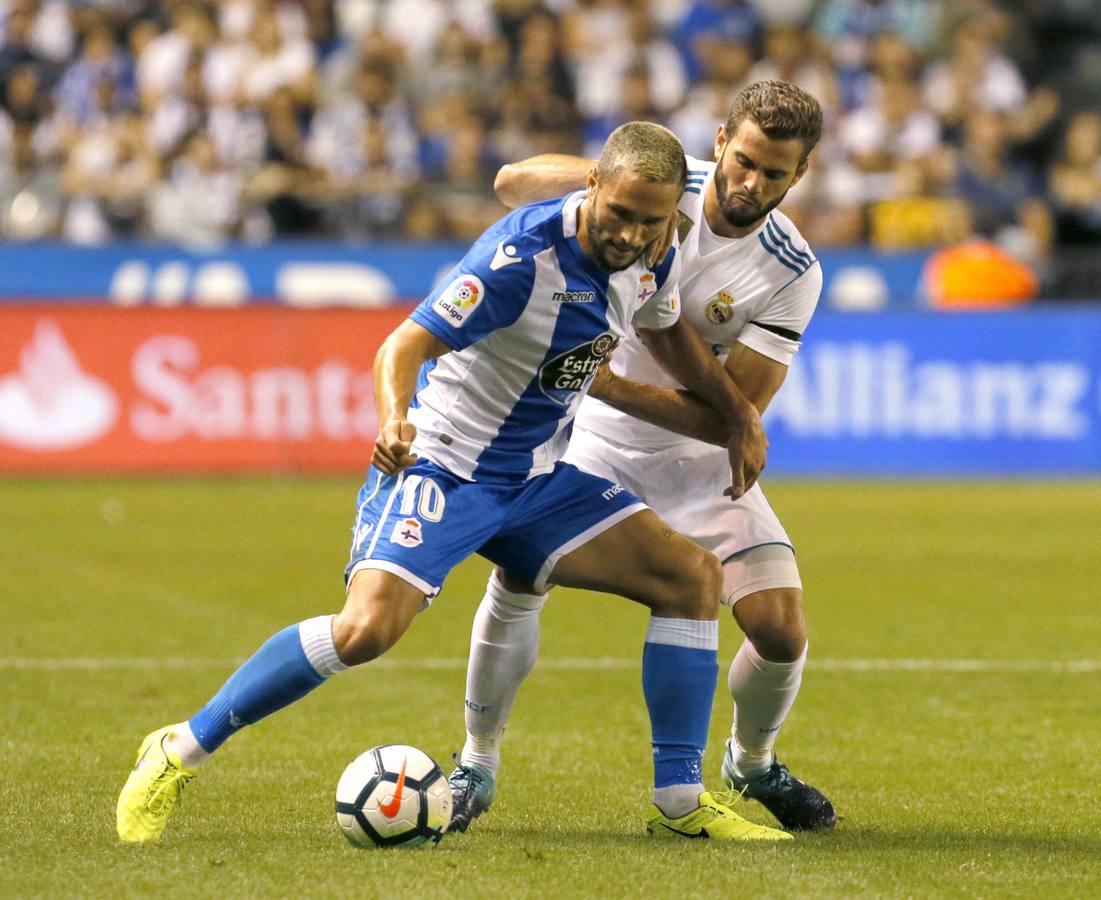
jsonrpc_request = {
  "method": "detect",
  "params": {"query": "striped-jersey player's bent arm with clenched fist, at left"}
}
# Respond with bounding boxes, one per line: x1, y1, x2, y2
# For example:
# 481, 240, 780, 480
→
371, 318, 451, 475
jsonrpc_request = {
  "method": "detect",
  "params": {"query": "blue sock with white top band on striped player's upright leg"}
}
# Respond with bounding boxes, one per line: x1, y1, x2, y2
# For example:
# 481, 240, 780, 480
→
642, 617, 719, 788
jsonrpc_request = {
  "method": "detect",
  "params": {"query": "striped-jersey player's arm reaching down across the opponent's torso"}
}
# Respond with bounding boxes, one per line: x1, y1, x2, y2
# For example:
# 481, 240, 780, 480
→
641, 318, 768, 499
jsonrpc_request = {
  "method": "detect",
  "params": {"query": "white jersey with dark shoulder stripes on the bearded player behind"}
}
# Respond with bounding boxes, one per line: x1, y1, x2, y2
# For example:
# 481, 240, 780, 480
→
577, 156, 822, 449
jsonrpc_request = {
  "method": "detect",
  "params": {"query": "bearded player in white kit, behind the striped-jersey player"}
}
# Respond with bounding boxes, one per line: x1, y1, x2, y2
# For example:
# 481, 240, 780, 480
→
451, 82, 837, 831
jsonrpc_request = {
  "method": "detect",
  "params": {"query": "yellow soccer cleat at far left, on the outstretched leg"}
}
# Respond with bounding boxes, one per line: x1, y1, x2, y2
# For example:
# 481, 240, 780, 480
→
115, 725, 196, 844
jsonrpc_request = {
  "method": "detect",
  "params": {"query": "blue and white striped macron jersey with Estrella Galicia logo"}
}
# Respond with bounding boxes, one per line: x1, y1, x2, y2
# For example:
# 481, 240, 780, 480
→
408, 192, 680, 481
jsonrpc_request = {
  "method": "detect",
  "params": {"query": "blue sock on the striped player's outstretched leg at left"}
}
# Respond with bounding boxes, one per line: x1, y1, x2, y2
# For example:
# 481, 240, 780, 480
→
188, 625, 325, 753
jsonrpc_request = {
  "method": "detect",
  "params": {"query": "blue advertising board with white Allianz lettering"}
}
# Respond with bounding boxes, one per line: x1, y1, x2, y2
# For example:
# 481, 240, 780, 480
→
765, 307, 1101, 477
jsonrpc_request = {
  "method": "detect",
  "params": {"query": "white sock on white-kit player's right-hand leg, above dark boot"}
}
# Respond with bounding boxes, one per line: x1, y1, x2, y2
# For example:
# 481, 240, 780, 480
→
727, 640, 809, 777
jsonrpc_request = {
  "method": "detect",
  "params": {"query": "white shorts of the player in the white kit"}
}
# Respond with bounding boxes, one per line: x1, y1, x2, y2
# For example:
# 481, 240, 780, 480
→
563, 429, 803, 604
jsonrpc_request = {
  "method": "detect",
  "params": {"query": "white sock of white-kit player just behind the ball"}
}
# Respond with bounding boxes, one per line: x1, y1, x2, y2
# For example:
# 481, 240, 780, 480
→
461, 571, 547, 773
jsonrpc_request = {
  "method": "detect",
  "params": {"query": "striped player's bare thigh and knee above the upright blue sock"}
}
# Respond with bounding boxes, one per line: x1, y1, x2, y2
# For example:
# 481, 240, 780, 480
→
551, 509, 721, 619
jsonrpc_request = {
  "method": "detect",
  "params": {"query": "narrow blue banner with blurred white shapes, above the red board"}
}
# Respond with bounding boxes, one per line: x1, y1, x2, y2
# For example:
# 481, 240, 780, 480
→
0, 241, 928, 308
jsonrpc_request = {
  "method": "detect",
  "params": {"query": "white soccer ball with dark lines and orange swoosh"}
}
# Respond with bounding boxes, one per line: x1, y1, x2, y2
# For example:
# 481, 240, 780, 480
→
337, 744, 451, 847
